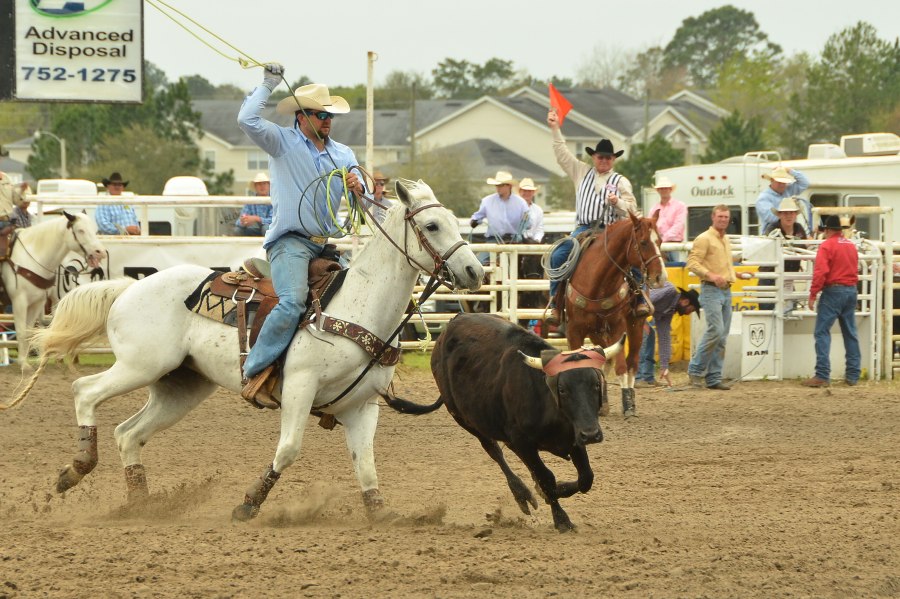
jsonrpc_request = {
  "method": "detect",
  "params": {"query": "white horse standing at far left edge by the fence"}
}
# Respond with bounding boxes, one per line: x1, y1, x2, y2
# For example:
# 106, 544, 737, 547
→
0, 212, 106, 370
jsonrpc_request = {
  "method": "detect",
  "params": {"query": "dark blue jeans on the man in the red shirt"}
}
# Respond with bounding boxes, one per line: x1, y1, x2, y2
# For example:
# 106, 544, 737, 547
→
814, 286, 862, 382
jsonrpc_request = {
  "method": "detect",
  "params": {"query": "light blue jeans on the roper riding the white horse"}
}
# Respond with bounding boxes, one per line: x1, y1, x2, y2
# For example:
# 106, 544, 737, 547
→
244, 234, 323, 378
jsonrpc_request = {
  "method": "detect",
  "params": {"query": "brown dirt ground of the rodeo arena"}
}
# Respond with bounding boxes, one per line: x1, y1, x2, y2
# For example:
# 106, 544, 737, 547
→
0, 366, 900, 598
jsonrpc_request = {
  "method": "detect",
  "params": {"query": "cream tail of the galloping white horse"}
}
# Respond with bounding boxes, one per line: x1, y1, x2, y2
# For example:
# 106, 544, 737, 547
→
0, 278, 135, 410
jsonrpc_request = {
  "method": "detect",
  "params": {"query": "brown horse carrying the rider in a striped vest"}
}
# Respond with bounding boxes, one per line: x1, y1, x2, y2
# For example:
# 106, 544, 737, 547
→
557, 215, 666, 418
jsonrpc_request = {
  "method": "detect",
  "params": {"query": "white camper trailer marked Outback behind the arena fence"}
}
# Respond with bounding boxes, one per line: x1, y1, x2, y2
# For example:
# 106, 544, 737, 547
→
643, 133, 900, 241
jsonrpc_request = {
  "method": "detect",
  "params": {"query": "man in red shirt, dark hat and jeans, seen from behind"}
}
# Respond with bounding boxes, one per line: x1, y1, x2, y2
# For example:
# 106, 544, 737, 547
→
803, 214, 861, 387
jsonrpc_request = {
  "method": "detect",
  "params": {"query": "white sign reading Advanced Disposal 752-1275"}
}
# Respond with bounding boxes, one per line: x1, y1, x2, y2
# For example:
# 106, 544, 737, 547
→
15, 0, 144, 102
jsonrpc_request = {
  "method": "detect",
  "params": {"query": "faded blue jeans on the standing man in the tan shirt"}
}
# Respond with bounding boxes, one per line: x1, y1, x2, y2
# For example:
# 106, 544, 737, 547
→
688, 283, 731, 385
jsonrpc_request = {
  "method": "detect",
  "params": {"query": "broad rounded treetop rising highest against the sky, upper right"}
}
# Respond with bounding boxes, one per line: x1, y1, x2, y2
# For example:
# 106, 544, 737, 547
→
664, 5, 781, 88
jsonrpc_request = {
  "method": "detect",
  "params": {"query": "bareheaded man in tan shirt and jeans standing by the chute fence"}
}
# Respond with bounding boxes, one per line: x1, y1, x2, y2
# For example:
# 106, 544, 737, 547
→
687, 204, 737, 391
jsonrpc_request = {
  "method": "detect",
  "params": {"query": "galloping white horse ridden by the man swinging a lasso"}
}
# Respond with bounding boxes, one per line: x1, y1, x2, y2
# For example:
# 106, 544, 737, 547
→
8, 180, 484, 520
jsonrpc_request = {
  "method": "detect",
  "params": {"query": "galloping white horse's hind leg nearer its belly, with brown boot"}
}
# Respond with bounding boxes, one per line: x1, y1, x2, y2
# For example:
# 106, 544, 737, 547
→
115, 368, 216, 501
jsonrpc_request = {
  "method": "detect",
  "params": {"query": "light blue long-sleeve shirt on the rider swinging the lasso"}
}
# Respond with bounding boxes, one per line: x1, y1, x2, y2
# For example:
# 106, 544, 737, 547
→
238, 85, 359, 249
